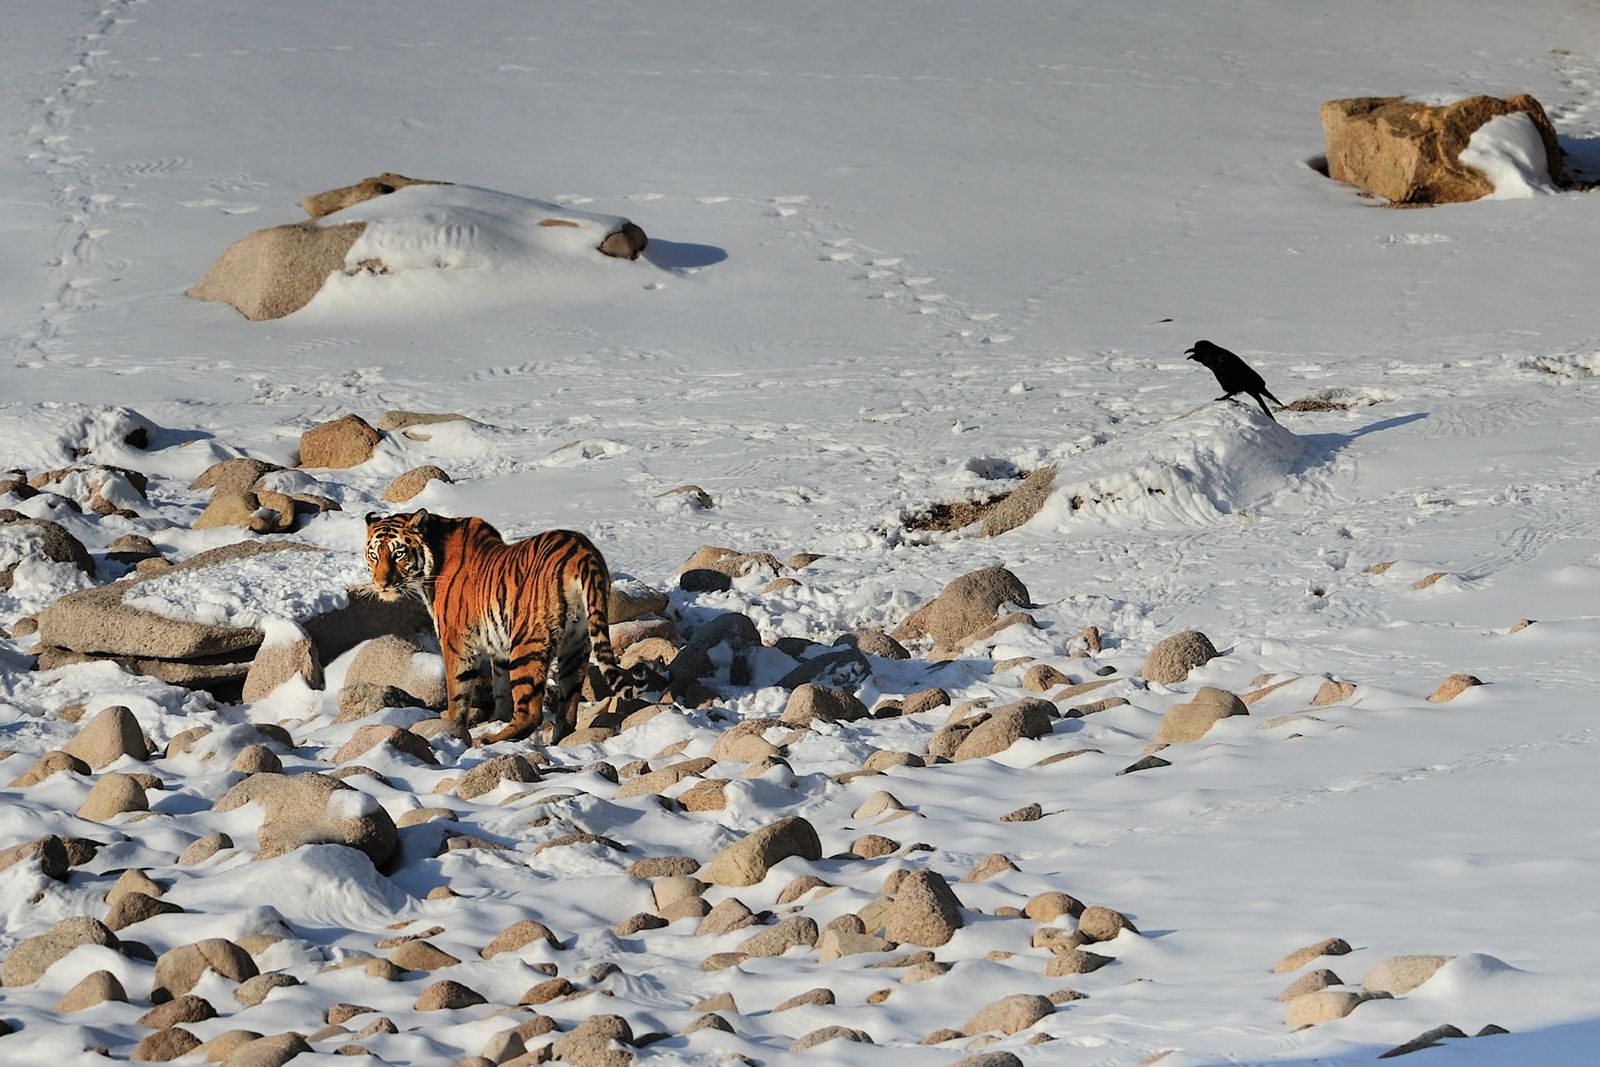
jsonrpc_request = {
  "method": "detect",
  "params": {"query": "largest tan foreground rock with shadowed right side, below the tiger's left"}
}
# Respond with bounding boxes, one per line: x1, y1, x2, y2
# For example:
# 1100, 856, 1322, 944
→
213, 773, 397, 865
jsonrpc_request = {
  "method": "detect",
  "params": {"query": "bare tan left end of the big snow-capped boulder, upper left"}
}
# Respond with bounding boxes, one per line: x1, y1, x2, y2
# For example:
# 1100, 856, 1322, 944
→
186, 221, 366, 322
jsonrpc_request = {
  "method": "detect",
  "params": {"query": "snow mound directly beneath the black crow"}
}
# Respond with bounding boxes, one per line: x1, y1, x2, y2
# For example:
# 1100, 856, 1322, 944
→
1029, 403, 1306, 530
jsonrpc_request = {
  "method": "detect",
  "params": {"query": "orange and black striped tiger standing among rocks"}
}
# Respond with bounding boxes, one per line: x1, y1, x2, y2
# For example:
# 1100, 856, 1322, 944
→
366, 510, 642, 744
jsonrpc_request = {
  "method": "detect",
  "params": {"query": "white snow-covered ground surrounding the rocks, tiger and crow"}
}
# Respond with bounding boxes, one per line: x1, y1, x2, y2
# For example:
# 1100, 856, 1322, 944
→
0, 0, 1600, 1067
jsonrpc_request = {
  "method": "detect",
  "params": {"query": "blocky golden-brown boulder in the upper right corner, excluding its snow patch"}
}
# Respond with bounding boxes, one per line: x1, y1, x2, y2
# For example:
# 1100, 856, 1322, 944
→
1322, 93, 1566, 203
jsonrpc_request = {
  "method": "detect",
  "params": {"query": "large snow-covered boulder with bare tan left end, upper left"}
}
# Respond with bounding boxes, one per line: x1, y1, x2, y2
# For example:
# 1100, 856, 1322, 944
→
187, 174, 646, 320
